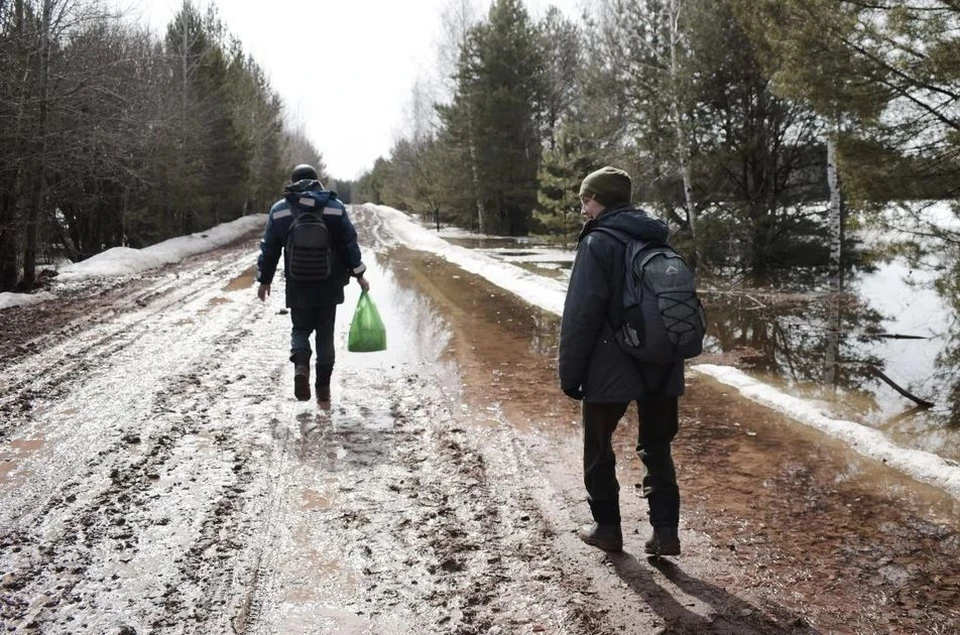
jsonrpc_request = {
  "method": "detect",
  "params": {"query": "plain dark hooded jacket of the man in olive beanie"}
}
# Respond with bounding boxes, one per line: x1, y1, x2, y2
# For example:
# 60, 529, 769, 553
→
558, 205, 684, 403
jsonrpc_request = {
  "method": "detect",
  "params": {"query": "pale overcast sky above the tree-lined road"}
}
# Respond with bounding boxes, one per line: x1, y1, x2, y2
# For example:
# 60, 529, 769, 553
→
134, 0, 584, 179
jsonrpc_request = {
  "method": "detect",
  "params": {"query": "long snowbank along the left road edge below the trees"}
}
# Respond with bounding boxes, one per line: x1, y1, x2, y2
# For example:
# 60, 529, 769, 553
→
58, 214, 267, 281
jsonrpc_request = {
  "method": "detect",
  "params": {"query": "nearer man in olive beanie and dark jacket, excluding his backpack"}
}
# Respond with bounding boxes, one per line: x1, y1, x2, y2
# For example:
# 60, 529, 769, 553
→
559, 167, 684, 556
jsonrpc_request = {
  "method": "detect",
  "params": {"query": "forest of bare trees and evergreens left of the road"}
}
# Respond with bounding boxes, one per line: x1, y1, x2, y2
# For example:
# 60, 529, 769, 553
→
0, 0, 326, 292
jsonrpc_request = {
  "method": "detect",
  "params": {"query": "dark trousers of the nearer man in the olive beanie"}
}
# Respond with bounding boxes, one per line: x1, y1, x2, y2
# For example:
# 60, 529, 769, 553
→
582, 395, 680, 527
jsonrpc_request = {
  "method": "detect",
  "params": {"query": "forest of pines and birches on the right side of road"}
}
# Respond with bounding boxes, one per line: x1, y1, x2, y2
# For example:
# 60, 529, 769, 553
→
355, 0, 960, 281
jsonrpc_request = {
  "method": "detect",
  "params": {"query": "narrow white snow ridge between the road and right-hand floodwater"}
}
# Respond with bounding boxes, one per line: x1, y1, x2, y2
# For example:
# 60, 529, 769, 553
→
369, 205, 960, 498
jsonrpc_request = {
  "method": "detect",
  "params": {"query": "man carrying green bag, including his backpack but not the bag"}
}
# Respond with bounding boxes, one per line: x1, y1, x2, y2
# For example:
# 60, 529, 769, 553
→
257, 164, 370, 403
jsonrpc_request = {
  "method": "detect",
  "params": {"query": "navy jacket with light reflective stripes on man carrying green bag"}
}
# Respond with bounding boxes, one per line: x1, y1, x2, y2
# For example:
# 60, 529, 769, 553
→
257, 180, 367, 308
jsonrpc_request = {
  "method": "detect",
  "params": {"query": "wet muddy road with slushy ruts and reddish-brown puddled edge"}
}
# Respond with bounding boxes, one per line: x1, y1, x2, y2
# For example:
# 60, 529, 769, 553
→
0, 209, 960, 635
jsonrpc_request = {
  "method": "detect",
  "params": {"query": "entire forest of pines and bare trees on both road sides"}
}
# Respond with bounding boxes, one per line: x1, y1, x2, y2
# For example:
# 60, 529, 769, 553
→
0, 0, 960, 291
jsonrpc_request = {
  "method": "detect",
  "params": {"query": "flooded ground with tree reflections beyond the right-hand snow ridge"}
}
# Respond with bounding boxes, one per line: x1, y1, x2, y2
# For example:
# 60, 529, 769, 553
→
441, 224, 960, 460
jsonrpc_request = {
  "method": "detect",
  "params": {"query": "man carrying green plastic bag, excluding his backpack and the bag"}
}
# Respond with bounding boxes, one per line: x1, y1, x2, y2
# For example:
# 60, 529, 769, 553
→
257, 164, 370, 402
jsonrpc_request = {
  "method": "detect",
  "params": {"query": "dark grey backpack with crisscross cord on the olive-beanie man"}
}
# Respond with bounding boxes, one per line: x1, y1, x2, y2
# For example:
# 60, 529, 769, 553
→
597, 227, 707, 364
